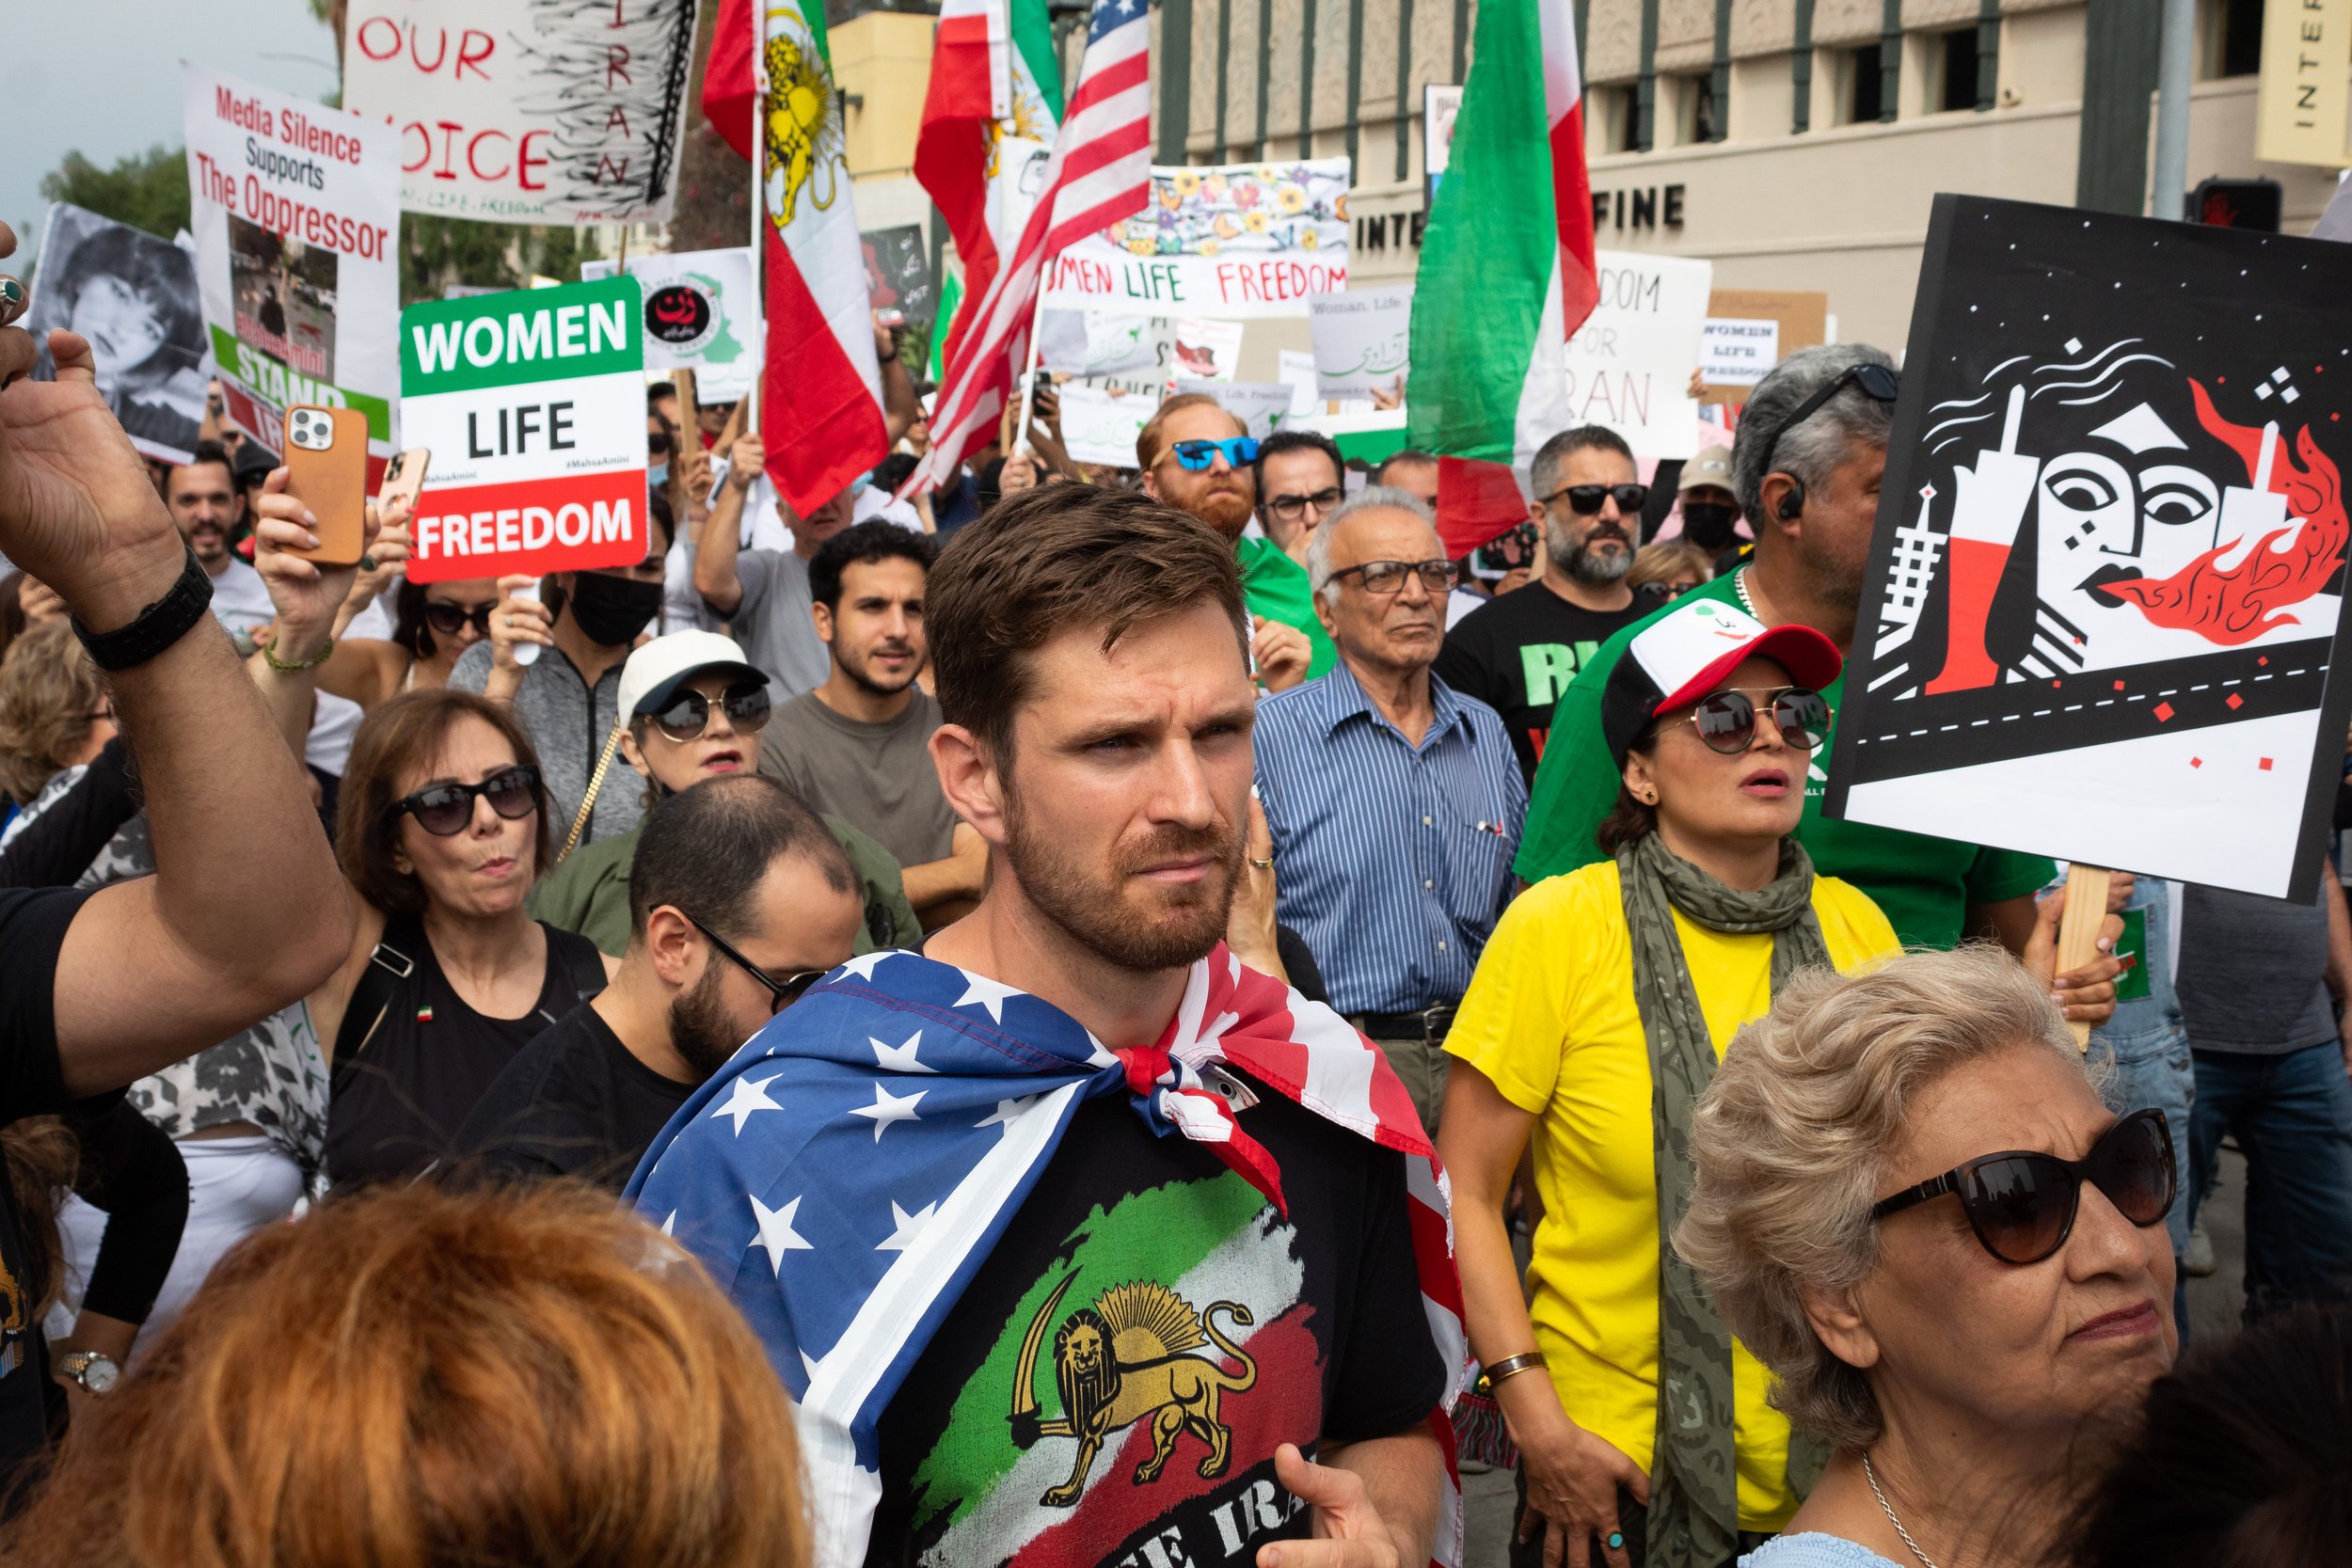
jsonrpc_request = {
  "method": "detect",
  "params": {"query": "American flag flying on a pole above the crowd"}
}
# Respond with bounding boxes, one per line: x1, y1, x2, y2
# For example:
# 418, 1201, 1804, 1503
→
906, 0, 1152, 491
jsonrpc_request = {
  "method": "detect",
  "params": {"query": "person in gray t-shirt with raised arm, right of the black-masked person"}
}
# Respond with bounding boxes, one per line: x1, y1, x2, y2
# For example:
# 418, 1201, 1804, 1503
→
694, 435, 837, 707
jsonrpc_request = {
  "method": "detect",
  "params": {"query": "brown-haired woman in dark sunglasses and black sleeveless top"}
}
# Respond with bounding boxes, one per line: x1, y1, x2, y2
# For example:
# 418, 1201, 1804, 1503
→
310, 689, 610, 1187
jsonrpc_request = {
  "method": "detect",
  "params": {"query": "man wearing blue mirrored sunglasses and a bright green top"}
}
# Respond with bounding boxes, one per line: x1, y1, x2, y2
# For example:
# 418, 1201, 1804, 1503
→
1136, 392, 1339, 691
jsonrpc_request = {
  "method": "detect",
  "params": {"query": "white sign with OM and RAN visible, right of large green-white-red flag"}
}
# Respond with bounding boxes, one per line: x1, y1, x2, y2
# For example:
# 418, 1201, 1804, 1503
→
1566, 251, 1715, 458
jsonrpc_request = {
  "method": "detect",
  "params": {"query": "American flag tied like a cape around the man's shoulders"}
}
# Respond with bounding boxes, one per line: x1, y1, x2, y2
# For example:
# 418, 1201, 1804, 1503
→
628, 942, 1466, 1568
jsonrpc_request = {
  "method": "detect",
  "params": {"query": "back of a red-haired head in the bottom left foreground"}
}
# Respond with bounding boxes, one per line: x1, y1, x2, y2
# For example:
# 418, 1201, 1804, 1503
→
0, 1185, 807, 1568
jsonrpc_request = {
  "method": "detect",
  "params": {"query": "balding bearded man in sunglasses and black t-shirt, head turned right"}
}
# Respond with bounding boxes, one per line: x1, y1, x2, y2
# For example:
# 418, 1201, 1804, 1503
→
456, 770, 861, 1192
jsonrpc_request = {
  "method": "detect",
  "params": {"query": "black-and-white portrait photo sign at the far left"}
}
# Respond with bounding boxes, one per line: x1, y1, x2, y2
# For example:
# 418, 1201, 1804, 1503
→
22, 202, 205, 463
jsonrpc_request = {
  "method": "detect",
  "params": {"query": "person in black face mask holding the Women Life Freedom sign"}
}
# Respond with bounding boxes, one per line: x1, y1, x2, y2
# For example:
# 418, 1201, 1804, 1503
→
450, 496, 671, 848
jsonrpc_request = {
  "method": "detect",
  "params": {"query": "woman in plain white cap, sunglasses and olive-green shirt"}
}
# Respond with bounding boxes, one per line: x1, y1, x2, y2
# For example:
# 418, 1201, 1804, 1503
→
530, 632, 922, 959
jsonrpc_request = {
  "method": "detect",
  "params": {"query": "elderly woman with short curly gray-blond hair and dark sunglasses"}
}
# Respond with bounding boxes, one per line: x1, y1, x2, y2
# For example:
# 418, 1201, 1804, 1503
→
1675, 947, 2176, 1568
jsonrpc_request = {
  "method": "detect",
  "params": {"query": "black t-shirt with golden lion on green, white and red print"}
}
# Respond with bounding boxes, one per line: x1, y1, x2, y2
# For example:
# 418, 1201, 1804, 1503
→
866, 1071, 1444, 1568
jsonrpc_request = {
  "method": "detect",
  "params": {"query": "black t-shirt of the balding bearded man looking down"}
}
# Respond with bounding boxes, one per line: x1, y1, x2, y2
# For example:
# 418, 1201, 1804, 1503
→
456, 1002, 694, 1192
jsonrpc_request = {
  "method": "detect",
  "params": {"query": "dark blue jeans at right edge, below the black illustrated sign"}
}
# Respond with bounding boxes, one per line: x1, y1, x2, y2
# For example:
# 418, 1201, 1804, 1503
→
2190, 1041, 2352, 1323
